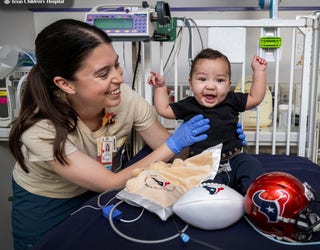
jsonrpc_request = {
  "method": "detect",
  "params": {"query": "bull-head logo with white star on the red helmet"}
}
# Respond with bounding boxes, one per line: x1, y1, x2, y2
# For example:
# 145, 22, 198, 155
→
252, 190, 290, 222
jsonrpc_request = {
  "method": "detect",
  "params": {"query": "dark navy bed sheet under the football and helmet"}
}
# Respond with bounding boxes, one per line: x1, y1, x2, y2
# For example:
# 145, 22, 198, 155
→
35, 155, 320, 250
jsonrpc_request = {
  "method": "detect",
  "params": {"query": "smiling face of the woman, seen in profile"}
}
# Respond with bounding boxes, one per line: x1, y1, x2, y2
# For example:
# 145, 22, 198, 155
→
71, 44, 123, 108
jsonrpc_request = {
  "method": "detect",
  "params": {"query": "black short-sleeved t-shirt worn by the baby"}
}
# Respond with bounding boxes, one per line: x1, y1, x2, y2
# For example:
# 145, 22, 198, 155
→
170, 91, 248, 156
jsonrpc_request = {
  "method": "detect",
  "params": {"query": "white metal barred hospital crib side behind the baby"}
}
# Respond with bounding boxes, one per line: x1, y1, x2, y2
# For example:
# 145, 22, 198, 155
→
122, 13, 320, 162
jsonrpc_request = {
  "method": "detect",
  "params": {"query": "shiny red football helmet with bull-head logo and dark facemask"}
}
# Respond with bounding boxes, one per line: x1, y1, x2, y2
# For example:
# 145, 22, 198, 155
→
244, 172, 320, 241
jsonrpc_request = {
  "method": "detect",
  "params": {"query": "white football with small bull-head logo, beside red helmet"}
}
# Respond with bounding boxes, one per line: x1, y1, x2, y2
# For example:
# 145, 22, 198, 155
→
173, 182, 244, 230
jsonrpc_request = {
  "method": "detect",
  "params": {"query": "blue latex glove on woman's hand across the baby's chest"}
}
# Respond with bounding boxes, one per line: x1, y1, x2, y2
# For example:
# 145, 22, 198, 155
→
166, 115, 210, 154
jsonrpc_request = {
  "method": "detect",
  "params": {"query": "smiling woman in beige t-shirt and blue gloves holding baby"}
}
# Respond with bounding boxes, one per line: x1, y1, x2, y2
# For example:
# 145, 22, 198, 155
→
9, 19, 209, 249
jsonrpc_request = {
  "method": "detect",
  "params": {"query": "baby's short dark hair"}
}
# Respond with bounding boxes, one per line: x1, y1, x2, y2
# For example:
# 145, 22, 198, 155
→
189, 48, 231, 79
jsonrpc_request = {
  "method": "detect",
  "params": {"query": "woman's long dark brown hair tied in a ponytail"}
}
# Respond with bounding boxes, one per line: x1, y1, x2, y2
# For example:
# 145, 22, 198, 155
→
9, 19, 111, 172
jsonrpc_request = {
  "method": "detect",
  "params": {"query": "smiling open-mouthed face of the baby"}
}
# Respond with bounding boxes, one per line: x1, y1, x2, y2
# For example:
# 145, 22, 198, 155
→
189, 58, 231, 108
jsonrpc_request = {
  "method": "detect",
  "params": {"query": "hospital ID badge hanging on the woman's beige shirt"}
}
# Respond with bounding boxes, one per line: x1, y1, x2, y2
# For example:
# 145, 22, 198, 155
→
97, 136, 117, 170
